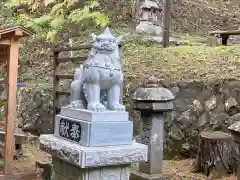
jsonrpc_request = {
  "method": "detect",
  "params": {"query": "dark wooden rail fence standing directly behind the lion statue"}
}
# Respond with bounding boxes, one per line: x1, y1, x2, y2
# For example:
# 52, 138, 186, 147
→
51, 44, 123, 132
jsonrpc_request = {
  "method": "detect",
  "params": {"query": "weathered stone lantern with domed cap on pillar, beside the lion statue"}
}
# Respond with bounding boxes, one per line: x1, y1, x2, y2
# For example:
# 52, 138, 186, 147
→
131, 78, 174, 180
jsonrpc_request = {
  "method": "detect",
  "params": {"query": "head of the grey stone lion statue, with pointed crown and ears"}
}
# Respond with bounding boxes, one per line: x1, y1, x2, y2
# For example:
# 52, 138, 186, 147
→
92, 28, 122, 52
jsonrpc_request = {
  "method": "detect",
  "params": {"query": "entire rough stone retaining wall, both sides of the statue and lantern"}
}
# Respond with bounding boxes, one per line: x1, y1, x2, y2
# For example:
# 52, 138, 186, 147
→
16, 80, 240, 158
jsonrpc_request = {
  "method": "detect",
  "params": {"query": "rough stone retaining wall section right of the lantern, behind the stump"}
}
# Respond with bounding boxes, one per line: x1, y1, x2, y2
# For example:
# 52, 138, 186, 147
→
133, 80, 240, 158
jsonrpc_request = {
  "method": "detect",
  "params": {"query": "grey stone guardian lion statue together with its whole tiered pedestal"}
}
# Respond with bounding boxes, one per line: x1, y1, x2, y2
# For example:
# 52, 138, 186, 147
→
40, 28, 147, 180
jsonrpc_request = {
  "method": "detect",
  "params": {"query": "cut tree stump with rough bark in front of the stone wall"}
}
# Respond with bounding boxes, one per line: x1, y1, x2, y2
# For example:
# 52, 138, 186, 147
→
194, 131, 240, 179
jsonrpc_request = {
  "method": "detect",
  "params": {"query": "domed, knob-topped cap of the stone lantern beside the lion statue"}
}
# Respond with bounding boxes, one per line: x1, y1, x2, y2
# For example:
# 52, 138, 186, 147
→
133, 77, 175, 102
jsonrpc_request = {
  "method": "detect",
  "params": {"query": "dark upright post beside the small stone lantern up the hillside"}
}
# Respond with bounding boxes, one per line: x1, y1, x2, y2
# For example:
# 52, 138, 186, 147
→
163, 0, 172, 48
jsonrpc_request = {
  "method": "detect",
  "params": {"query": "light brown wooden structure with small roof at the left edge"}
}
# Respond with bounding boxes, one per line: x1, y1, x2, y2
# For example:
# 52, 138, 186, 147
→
0, 26, 36, 180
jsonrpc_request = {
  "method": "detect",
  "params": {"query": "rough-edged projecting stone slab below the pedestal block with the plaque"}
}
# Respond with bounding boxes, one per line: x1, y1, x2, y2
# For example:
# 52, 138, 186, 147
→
40, 135, 147, 168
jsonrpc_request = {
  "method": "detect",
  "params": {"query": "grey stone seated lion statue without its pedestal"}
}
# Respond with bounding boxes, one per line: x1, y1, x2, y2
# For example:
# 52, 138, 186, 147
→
70, 28, 125, 111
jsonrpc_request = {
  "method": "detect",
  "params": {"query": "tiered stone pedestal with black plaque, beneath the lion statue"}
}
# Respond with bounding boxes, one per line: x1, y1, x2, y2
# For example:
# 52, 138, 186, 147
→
40, 108, 147, 180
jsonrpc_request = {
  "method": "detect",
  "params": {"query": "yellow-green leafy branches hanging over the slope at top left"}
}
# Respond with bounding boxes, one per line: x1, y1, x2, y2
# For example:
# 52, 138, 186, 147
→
7, 0, 109, 42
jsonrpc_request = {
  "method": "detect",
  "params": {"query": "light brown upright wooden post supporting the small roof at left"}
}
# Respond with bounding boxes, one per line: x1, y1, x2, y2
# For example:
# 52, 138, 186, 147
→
4, 37, 19, 175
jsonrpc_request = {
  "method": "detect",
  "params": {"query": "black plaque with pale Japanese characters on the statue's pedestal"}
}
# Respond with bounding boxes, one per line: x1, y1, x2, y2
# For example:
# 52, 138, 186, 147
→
59, 119, 81, 142
